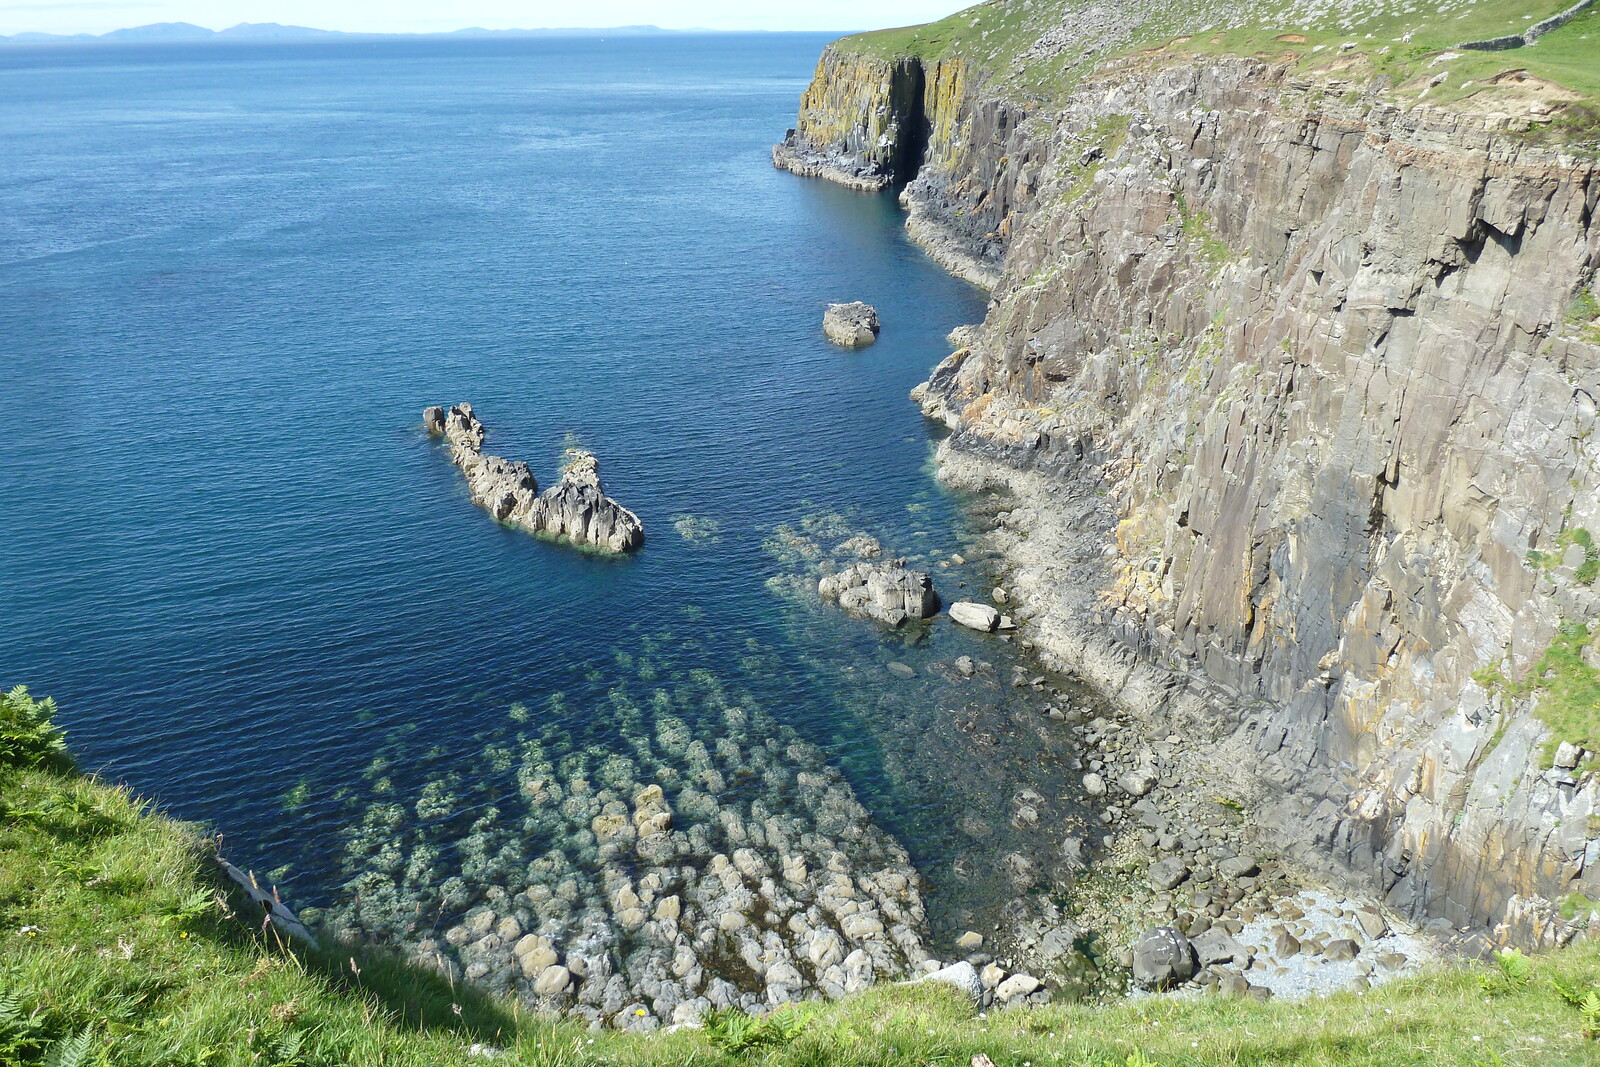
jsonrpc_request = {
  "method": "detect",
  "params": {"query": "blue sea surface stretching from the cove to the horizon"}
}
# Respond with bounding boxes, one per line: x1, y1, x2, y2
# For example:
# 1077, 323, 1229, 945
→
0, 34, 1088, 947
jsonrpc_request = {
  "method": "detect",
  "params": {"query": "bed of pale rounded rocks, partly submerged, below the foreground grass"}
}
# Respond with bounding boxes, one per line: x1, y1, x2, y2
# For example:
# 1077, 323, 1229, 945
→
331, 672, 930, 1030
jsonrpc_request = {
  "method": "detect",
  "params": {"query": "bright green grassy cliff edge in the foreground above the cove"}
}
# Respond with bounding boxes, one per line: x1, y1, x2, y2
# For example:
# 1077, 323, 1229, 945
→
9, 691, 1600, 1067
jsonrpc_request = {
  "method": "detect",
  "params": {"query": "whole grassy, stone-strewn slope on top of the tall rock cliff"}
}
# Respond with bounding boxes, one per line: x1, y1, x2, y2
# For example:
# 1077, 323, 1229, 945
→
838, 0, 1600, 114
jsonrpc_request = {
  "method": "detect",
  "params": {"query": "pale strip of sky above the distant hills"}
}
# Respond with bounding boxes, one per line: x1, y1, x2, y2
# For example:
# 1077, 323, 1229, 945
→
0, 0, 976, 34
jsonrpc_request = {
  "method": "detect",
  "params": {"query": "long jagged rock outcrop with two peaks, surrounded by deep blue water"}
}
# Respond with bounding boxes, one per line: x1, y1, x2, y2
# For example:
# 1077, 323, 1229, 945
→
422, 403, 645, 552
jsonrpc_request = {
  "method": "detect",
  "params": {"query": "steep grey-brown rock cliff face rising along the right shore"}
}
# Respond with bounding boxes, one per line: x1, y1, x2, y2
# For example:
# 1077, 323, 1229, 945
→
784, 41, 1600, 942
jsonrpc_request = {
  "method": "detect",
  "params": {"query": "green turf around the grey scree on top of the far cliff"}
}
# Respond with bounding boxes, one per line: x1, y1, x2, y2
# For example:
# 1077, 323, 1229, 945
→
837, 0, 1600, 139
